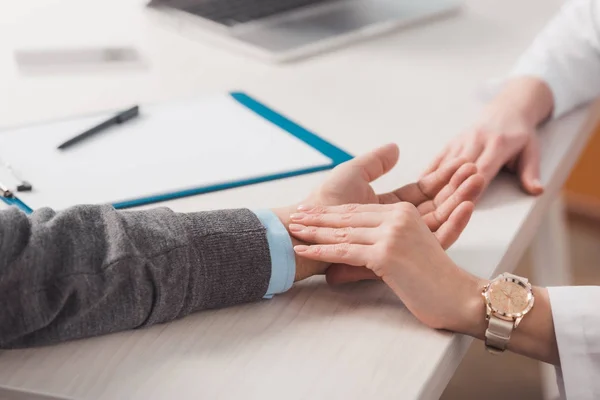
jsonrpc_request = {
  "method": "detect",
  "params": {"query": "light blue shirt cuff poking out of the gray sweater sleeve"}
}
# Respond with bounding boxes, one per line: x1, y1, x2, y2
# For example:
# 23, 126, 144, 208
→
253, 210, 296, 299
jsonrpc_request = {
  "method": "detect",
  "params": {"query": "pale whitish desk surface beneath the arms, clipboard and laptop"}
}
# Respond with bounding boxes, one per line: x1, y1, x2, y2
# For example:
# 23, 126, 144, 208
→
0, 0, 596, 400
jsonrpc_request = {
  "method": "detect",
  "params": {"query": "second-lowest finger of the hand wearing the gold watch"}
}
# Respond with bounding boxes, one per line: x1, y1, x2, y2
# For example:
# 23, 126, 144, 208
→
290, 224, 377, 244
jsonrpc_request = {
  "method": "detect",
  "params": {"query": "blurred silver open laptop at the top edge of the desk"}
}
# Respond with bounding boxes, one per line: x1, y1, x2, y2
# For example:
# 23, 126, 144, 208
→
148, 0, 461, 62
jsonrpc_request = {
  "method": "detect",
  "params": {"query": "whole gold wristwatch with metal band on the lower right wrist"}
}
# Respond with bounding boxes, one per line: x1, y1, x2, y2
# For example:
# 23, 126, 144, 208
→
481, 272, 535, 354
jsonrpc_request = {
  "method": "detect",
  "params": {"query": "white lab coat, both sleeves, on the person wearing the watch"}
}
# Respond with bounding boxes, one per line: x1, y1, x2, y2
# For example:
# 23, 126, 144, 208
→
511, 0, 600, 400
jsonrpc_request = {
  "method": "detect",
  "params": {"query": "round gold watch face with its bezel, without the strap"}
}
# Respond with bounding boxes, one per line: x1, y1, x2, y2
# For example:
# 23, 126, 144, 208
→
486, 278, 533, 317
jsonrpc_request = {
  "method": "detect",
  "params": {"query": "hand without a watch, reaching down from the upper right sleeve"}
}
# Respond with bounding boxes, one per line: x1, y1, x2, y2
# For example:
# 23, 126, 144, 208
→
425, 78, 553, 195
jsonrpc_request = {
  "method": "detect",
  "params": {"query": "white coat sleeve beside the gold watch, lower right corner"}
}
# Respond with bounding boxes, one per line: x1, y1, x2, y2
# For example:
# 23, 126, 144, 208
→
548, 286, 600, 400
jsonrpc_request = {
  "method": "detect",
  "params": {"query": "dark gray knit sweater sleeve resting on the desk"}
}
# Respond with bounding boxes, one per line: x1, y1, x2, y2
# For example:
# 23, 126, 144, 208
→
0, 206, 271, 348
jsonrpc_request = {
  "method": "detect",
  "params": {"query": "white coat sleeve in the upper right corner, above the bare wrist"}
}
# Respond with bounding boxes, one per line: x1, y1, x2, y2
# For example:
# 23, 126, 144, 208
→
510, 0, 600, 117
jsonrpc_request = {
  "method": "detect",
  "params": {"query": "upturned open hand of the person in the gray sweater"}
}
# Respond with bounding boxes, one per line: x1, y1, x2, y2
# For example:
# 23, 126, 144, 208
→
303, 144, 483, 284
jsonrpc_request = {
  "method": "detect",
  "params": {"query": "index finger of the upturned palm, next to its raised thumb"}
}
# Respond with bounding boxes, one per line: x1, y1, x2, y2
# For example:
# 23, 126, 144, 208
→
379, 158, 465, 206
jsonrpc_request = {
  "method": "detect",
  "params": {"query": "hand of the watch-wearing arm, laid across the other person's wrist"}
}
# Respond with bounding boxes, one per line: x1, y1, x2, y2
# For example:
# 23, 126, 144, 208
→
289, 201, 485, 336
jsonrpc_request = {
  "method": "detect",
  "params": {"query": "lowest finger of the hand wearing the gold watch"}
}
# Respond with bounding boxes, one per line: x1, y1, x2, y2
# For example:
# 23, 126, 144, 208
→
294, 243, 371, 266
